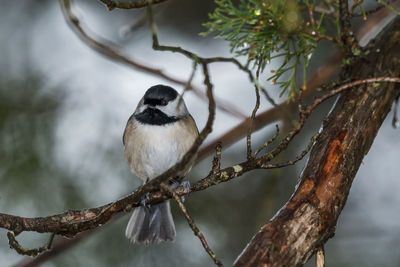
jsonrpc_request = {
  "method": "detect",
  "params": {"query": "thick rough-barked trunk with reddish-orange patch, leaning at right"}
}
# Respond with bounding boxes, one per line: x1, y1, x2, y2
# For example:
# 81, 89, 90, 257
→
235, 20, 400, 266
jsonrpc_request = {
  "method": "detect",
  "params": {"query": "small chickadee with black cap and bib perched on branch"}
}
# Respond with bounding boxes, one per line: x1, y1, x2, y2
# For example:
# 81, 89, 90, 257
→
123, 84, 199, 245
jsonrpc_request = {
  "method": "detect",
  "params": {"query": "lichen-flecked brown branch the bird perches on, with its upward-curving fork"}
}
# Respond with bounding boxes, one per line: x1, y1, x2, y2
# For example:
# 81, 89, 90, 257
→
0, 75, 400, 247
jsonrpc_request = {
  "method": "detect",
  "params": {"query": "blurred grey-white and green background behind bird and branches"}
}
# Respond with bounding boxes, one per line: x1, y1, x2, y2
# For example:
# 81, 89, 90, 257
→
0, 0, 400, 266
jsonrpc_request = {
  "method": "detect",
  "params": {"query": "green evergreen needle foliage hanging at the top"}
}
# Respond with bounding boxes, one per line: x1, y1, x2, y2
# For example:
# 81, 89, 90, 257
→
202, 0, 334, 98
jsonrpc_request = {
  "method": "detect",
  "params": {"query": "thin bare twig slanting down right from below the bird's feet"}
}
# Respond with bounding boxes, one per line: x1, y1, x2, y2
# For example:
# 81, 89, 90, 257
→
161, 184, 224, 267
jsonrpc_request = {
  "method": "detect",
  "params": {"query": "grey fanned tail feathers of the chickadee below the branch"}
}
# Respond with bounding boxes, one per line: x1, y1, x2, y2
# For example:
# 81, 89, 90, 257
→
125, 200, 175, 245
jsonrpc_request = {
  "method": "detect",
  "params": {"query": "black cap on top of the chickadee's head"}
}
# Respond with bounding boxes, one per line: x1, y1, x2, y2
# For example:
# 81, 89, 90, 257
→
143, 84, 178, 106
